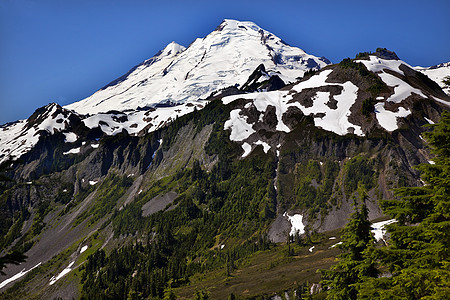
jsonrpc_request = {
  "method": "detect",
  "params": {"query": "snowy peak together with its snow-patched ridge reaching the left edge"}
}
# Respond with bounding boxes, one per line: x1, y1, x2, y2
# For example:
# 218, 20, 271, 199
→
0, 20, 330, 163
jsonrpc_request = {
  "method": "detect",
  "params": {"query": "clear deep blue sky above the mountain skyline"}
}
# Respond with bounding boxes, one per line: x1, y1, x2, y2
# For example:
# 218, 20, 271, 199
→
0, 0, 450, 124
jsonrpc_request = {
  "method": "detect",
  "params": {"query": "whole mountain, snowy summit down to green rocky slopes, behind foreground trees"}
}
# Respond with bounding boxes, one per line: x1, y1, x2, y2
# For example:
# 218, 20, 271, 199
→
0, 20, 450, 299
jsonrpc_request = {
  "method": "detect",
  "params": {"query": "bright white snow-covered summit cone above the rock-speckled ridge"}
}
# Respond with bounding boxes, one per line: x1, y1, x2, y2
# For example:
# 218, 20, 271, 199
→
66, 19, 329, 114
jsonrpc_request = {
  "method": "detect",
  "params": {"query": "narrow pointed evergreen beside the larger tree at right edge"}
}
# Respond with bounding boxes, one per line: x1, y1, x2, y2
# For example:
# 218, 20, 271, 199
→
322, 184, 378, 300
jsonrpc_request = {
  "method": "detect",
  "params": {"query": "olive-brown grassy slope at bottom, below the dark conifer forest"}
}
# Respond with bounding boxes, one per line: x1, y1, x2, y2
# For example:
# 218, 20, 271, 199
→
174, 231, 340, 299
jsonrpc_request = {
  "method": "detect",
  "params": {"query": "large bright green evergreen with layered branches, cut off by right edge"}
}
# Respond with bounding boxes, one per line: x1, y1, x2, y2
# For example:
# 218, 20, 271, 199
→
359, 112, 450, 299
